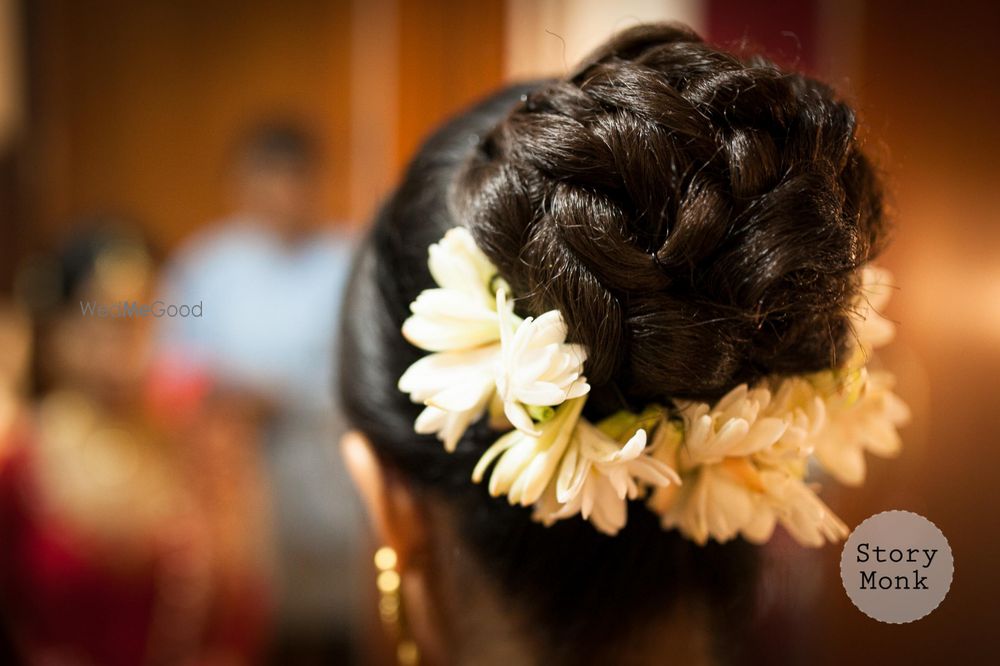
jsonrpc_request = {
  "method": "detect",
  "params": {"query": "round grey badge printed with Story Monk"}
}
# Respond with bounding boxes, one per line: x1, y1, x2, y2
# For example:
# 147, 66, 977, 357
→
840, 511, 954, 624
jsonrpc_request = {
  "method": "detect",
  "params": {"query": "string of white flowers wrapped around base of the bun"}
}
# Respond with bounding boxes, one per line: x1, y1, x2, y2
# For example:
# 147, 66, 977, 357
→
399, 228, 909, 546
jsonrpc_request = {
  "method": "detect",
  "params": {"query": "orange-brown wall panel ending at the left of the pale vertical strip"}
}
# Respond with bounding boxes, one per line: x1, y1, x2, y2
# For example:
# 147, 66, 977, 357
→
28, 0, 350, 252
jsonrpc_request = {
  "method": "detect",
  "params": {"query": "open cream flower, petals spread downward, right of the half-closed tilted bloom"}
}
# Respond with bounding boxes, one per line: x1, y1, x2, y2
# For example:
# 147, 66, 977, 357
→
535, 415, 680, 536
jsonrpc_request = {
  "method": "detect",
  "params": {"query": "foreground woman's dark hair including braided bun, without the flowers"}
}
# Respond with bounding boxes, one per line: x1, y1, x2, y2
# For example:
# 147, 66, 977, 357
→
342, 26, 884, 663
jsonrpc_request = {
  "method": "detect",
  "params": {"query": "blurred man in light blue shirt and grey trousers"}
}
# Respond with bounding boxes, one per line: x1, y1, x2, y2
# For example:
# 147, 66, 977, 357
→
158, 121, 359, 645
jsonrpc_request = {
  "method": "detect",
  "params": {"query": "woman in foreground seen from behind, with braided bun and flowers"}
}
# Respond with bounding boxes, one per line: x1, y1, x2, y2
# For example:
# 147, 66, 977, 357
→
340, 25, 902, 665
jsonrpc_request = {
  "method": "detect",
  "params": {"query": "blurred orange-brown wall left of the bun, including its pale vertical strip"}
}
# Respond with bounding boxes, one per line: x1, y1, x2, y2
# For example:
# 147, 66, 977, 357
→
21, 0, 504, 249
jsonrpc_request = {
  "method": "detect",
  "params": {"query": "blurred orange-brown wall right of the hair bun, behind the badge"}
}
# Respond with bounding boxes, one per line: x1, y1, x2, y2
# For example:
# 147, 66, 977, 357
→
819, 0, 1000, 664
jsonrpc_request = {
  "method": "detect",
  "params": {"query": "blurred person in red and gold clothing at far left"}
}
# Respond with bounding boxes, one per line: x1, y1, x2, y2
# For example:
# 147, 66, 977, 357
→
0, 226, 267, 666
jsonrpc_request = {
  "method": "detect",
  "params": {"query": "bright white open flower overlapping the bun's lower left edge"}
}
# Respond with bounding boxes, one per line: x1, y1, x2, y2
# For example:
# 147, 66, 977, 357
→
496, 287, 590, 437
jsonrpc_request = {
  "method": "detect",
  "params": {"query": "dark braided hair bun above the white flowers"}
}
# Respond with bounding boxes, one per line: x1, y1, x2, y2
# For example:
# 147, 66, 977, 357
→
452, 25, 884, 407
